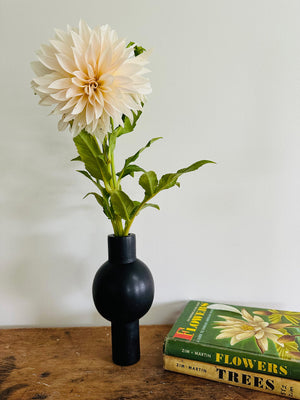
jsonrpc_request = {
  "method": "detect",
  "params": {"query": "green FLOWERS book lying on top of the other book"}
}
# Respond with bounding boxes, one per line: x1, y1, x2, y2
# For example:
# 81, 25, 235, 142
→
164, 301, 300, 380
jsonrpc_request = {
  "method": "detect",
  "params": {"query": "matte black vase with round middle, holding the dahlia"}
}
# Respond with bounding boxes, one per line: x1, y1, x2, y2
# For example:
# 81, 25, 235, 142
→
93, 234, 154, 365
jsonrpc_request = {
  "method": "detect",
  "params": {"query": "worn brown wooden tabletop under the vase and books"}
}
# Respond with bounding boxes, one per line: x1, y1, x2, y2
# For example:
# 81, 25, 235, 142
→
0, 325, 290, 400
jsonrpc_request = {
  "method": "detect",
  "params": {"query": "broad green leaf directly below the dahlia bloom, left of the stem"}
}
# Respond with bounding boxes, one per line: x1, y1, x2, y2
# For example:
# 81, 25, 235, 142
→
73, 131, 110, 180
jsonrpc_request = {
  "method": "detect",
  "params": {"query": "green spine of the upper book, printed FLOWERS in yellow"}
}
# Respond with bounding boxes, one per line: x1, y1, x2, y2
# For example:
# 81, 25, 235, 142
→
164, 338, 300, 380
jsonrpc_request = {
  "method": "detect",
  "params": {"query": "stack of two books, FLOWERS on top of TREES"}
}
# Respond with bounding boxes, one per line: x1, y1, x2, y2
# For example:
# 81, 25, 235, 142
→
164, 301, 300, 399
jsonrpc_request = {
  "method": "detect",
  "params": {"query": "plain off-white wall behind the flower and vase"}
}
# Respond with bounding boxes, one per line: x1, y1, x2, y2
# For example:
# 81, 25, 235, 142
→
0, 0, 300, 327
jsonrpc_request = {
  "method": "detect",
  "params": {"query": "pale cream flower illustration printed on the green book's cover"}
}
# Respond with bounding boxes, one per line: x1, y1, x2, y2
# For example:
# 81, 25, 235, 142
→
215, 309, 289, 353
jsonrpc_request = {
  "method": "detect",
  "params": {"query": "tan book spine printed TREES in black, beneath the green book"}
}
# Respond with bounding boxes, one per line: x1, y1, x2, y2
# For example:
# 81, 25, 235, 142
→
164, 355, 300, 399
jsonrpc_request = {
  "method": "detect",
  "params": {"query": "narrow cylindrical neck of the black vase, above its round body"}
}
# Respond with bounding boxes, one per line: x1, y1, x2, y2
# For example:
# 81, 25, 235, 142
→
108, 233, 136, 264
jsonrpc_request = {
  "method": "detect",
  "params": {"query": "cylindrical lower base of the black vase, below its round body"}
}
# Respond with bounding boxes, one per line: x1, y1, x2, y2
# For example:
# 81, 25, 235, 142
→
111, 320, 140, 366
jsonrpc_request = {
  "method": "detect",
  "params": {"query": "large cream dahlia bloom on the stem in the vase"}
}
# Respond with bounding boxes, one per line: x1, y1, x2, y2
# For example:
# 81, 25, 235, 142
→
32, 21, 151, 140
